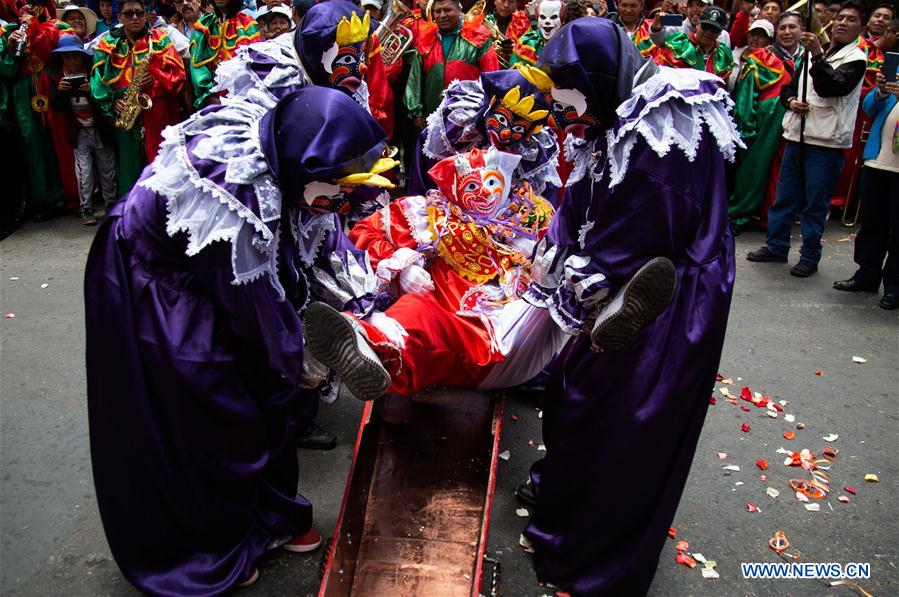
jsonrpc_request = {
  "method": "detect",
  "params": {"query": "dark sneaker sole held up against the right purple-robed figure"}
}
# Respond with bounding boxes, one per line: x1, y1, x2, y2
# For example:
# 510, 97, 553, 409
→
590, 257, 677, 352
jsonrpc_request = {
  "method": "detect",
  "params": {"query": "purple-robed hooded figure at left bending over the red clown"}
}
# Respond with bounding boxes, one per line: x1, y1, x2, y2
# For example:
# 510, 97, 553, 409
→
85, 87, 392, 595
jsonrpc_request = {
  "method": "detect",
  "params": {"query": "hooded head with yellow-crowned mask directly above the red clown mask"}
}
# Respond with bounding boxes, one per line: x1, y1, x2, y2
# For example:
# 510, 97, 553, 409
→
477, 69, 550, 147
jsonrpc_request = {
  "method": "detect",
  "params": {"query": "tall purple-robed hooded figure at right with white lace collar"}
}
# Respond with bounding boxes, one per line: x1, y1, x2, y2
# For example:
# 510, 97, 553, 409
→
519, 19, 739, 595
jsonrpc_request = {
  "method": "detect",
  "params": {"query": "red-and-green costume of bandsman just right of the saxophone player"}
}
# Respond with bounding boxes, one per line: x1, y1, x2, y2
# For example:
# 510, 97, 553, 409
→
190, 11, 259, 108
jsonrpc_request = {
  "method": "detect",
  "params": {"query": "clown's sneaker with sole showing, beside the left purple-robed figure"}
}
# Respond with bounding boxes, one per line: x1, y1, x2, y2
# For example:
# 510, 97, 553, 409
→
303, 302, 390, 400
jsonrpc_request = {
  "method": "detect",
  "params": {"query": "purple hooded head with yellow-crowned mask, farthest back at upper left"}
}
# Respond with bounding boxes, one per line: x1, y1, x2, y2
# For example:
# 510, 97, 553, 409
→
293, 1, 371, 93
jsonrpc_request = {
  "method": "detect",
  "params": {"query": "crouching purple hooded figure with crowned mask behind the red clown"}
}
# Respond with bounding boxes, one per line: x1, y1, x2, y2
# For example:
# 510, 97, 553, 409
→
409, 67, 562, 201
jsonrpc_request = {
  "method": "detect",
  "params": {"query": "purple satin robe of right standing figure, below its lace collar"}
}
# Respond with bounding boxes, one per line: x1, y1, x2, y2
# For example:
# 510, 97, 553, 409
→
525, 132, 734, 595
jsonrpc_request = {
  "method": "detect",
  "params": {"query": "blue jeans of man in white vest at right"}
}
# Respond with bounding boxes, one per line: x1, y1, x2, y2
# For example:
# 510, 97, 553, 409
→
765, 141, 844, 265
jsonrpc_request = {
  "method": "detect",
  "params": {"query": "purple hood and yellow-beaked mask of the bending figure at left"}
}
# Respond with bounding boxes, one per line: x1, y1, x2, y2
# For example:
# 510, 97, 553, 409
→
259, 85, 398, 211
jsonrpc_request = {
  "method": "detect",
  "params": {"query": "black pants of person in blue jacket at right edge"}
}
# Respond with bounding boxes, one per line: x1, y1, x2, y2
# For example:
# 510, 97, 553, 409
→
853, 166, 899, 294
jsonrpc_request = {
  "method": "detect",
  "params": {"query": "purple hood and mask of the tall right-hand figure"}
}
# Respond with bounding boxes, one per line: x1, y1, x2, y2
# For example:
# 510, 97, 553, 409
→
537, 19, 644, 137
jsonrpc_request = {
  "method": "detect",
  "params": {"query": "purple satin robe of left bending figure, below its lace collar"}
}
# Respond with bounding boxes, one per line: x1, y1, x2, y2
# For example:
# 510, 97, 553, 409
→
85, 187, 316, 595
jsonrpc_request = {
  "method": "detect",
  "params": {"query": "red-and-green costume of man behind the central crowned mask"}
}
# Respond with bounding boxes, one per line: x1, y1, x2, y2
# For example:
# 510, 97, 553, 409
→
403, 15, 499, 118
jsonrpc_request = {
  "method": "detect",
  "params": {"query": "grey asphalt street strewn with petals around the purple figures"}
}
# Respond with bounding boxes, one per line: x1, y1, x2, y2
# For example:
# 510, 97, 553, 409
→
0, 217, 899, 597
